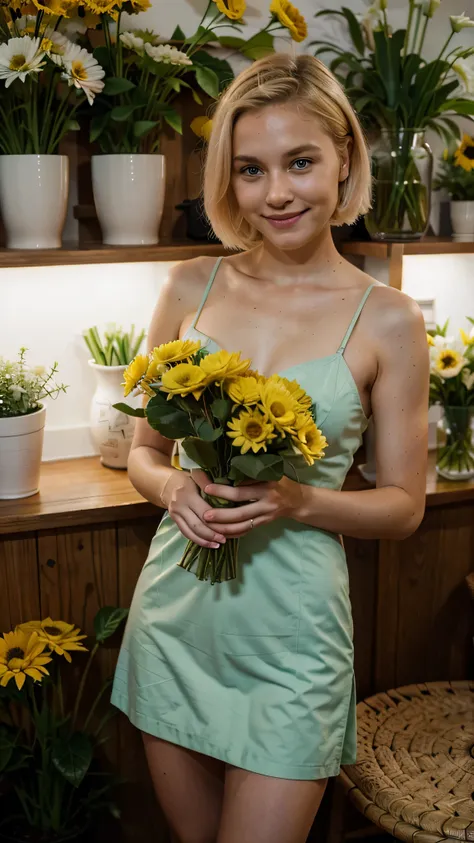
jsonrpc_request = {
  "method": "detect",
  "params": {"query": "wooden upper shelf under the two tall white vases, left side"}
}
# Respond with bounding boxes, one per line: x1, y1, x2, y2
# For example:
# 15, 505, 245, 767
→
0, 240, 227, 269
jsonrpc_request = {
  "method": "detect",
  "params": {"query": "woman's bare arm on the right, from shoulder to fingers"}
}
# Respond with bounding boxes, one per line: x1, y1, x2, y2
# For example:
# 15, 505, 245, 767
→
205, 295, 429, 539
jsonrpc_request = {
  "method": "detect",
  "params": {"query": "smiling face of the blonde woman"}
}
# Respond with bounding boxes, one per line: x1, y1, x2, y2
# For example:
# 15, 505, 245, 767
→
232, 104, 349, 250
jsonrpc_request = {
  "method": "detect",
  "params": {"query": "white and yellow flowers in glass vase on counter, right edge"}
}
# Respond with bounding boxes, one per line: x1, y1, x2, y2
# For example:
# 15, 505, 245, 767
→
427, 317, 474, 480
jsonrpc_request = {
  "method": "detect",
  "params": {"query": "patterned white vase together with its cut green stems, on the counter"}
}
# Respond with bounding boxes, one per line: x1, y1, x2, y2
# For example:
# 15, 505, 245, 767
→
83, 324, 145, 468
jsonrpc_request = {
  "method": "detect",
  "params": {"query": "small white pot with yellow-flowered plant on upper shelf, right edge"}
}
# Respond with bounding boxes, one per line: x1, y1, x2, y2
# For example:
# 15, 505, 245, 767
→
435, 134, 474, 243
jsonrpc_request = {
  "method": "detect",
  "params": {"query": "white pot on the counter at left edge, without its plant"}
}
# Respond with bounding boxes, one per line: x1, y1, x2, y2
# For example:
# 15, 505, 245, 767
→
0, 407, 46, 501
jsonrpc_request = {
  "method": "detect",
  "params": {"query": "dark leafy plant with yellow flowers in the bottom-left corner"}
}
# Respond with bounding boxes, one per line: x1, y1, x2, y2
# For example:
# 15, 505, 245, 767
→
0, 607, 127, 843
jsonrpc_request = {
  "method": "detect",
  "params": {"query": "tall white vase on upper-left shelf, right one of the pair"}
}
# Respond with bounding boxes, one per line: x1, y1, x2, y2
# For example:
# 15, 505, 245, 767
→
92, 153, 166, 246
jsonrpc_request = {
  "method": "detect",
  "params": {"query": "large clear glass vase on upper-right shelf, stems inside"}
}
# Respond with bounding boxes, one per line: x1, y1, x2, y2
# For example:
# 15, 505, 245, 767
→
365, 129, 433, 241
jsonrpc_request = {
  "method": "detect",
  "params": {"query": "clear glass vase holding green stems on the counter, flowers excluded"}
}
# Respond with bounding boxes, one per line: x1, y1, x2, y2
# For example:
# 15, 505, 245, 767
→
436, 406, 474, 480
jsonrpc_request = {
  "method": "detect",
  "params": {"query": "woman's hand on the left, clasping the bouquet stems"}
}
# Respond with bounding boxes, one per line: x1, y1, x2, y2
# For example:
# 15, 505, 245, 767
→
162, 471, 225, 548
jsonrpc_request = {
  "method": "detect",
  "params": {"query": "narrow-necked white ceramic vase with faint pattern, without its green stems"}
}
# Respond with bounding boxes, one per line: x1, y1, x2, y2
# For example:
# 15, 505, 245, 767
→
89, 360, 142, 468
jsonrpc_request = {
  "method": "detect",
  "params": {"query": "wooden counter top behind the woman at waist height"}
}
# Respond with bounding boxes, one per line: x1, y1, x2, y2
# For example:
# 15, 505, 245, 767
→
0, 454, 474, 534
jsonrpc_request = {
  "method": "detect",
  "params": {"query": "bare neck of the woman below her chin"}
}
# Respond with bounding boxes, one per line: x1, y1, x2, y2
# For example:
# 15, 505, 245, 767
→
249, 226, 343, 284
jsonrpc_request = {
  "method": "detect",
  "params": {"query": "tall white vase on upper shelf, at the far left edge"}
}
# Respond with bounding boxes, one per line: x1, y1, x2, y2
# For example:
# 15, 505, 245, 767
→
0, 155, 69, 249
